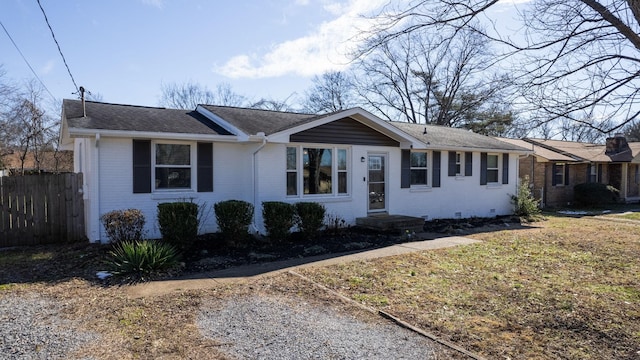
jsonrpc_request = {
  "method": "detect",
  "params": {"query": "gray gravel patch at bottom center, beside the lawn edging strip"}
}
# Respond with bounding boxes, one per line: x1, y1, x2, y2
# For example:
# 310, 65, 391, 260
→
197, 296, 436, 360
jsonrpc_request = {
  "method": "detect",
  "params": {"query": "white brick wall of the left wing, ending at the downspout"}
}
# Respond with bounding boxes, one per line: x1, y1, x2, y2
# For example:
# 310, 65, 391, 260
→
84, 137, 253, 243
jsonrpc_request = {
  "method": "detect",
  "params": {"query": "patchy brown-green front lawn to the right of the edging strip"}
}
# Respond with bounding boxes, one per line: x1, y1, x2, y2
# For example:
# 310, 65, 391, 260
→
301, 216, 640, 359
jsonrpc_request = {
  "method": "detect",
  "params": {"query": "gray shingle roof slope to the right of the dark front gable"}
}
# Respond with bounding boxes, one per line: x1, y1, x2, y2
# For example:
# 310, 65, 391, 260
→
391, 121, 530, 151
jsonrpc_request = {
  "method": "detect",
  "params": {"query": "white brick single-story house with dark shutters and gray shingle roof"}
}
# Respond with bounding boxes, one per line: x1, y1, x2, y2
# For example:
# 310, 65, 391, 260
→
60, 100, 529, 242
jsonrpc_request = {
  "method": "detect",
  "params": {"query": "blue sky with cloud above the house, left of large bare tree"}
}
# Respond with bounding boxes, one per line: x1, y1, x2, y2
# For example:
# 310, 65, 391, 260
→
0, 0, 526, 106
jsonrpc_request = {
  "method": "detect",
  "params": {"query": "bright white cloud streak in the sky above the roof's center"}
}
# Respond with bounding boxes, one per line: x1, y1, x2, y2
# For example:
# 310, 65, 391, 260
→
213, 0, 387, 78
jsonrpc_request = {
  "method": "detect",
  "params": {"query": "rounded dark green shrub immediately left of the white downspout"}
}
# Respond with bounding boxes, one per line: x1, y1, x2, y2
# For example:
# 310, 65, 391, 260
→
213, 200, 253, 246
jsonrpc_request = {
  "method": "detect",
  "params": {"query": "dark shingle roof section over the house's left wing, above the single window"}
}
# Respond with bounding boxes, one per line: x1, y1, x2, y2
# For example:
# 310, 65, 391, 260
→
62, 99, 231, 135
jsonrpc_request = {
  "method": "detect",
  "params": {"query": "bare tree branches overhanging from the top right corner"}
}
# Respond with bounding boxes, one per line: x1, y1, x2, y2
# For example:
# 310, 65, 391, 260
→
362, 0, 640, 133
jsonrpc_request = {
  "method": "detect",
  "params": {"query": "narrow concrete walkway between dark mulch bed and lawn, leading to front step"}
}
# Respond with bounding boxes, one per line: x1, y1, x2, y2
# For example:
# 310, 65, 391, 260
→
127, 236, 480, 298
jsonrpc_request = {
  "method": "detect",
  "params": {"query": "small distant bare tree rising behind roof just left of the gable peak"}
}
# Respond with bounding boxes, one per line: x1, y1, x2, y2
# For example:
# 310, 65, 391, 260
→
303, 71, 355, 114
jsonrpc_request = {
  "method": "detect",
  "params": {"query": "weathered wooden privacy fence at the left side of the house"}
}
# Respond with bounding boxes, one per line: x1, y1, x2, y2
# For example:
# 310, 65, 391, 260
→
0, 174, 85, 247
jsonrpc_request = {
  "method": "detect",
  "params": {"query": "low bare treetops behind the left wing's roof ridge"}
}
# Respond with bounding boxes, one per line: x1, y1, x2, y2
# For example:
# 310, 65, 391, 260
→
160, 82, 246, 109
